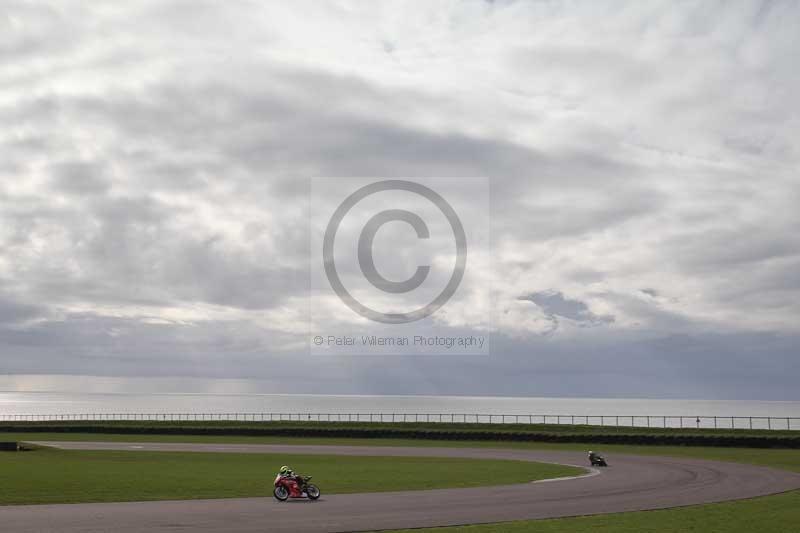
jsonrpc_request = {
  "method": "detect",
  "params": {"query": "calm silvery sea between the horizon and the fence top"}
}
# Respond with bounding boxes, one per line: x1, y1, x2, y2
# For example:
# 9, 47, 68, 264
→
0, 392, 800, 417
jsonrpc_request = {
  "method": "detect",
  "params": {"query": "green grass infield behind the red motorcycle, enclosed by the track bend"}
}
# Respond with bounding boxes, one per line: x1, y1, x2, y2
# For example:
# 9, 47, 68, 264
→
0, 448, 584, 505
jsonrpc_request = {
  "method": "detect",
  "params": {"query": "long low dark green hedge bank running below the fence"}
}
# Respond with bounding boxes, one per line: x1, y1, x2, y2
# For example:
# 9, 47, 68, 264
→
0, 422, 800, 448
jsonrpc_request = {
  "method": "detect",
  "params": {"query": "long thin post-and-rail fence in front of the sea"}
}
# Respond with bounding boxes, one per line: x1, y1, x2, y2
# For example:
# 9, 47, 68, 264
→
0, 413, 800, 430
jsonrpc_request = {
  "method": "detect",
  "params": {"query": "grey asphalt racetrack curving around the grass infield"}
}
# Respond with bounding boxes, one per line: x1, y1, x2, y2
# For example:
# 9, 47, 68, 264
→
0, 442, 800, 533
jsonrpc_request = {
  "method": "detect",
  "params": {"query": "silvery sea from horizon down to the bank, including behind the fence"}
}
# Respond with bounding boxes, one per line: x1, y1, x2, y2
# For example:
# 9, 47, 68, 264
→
0, 391, 800, 429
